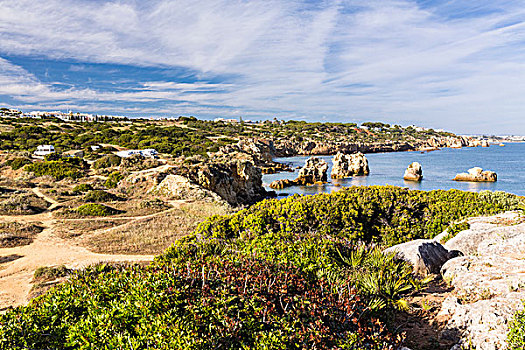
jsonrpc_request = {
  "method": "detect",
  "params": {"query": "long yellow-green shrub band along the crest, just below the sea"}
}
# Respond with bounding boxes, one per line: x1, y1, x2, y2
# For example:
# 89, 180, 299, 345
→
188, 186, 518, 245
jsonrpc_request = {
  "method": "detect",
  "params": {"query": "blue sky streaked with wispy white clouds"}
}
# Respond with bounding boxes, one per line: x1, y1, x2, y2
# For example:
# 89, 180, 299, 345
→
0, 0, 525, 135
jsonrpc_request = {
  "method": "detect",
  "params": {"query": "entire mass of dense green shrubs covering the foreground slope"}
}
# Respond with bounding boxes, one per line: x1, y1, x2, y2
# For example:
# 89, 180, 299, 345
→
0, 186, 518, 349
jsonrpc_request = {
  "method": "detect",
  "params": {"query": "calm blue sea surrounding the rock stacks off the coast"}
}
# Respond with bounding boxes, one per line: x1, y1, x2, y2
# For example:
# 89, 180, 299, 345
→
263, 143, 525, 196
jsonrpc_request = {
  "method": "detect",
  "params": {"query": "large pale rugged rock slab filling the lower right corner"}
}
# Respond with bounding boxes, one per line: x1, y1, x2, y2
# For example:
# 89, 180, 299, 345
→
438, 212, 525, 350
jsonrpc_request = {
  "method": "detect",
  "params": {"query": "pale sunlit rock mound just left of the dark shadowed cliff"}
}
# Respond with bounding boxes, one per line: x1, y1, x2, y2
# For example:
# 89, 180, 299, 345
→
148, 175, 225, 203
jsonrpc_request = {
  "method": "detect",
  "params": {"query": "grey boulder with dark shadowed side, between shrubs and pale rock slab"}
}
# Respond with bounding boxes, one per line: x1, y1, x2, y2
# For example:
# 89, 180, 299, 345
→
385, 239, 461, 276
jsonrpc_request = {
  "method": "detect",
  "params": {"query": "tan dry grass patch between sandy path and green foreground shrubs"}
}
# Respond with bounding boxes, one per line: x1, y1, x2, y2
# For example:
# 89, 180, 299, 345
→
83, 202, 230, 254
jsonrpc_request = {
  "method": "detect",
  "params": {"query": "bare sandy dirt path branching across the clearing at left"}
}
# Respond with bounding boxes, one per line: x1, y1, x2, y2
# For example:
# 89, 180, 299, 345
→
0, 188, 160, 310
